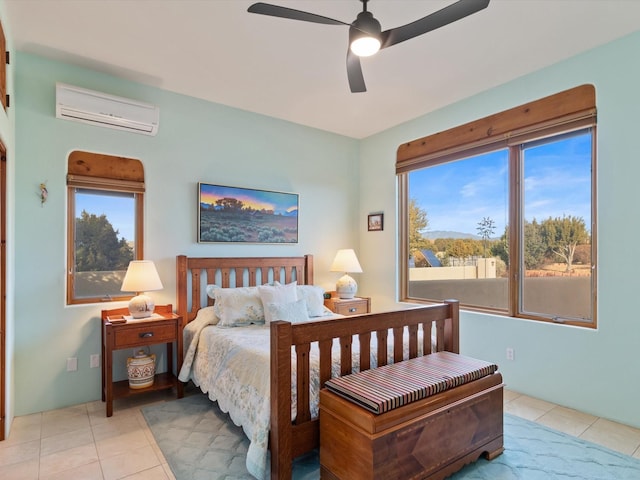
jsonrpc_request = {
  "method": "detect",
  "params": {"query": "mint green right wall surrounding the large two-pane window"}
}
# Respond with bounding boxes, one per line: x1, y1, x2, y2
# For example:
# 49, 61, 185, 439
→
359, 32, 640, 427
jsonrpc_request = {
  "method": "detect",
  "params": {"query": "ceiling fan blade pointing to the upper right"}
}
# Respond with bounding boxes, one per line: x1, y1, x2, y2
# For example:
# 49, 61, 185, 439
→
380, 0, 489, 48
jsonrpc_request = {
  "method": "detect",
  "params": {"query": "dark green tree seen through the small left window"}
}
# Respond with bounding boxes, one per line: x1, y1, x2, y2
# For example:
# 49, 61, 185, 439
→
76, 210, 133, 272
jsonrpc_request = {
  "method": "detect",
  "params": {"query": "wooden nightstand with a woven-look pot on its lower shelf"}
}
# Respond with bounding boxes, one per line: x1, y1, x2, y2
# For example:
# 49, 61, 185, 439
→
102, 305, 184, 417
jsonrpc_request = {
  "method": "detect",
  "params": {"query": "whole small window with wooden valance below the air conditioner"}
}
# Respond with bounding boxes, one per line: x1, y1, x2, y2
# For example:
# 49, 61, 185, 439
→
67, 151, 144, 304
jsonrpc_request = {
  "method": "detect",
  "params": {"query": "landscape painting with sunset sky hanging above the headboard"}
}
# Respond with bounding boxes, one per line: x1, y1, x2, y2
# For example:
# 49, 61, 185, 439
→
198, 183, 298, 243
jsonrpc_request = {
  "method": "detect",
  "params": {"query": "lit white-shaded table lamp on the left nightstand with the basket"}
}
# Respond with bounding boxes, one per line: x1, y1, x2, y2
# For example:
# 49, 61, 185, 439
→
120, 260, 163, 318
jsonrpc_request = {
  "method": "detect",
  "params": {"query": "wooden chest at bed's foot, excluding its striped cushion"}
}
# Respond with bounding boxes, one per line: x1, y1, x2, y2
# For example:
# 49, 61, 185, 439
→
320, 356, 503, 480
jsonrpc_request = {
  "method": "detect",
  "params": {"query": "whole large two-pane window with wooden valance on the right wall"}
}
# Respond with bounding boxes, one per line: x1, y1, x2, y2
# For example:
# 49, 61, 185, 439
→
397, 86, 596, 326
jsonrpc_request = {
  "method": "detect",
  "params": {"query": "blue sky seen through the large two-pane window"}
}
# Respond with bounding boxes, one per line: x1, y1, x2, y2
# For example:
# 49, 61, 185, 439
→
409, 133, 591, 237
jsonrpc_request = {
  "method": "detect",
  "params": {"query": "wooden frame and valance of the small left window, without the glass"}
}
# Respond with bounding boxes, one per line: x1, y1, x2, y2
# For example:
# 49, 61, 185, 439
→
66, 150, 145, 305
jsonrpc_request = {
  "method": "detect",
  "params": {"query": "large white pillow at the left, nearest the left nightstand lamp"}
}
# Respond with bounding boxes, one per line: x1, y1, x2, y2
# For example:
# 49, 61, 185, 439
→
214, 287, 264, 327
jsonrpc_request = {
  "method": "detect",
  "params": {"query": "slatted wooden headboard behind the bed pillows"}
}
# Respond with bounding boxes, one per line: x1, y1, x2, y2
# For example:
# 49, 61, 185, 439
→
176, 255, 313, 324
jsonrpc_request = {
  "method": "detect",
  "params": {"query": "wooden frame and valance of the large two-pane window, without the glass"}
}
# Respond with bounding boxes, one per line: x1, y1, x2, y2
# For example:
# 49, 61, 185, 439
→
396, 85, 597, 328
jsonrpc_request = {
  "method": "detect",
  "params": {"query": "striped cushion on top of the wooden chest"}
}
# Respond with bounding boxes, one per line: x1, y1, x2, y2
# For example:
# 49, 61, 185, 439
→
325, 352, 498, 414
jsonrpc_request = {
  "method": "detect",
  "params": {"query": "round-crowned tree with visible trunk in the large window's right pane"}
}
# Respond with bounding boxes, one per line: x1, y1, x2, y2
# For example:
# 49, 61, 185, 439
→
540, 215, 589, 272
